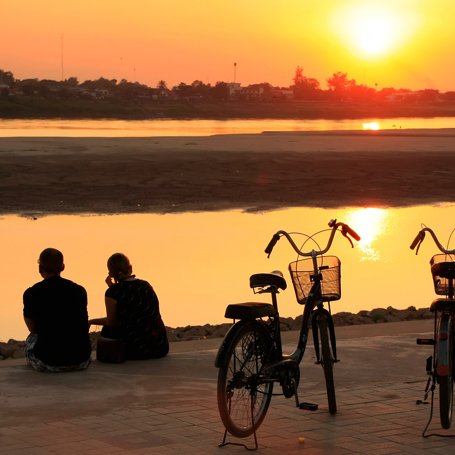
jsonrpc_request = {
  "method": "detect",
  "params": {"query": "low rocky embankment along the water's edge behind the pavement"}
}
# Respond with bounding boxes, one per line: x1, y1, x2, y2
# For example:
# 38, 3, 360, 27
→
0, 306, 434, 360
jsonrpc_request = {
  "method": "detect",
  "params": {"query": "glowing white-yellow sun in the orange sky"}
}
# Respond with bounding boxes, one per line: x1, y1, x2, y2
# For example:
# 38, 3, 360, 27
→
332, 2, 420, 58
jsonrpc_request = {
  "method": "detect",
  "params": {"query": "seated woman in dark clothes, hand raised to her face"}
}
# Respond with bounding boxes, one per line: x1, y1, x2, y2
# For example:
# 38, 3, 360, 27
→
88, 253, 169, 360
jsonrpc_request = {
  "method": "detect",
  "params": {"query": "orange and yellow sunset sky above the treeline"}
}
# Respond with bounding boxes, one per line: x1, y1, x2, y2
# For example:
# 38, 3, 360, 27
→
0, 0, 455, 92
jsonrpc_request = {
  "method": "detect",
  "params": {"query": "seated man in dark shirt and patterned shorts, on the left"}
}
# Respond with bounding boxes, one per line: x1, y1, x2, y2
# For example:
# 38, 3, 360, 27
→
24, 248, 92, 372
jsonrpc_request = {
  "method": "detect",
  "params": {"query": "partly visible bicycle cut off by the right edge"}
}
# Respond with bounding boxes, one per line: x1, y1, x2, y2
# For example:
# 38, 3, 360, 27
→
411, 227, 455, 437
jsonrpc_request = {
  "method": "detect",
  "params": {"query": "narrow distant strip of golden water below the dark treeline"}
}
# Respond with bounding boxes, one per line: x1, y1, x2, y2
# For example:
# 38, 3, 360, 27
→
0, 117, 455, 137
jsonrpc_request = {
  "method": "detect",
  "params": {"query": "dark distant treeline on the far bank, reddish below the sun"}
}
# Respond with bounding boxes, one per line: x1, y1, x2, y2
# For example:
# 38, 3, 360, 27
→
0, 67, 455, 119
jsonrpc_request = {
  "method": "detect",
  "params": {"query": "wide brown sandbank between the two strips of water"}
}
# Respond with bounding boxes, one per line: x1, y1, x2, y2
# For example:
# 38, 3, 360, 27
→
0, 129, 455, 216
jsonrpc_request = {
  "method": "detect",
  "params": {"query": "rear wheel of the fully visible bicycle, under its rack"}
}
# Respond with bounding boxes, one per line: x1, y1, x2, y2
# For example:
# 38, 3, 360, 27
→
217, 321, 273, 438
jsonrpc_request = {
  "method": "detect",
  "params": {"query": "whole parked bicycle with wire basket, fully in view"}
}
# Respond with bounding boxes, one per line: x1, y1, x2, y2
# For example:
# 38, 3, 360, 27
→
215, 220, 360, 448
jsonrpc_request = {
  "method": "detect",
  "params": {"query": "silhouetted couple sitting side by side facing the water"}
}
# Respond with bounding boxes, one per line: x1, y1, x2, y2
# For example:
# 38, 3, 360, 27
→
24, 248, 169, 372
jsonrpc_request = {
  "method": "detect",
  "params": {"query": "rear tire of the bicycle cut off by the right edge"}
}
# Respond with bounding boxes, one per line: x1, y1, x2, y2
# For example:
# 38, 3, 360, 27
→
438, 314, 454, 430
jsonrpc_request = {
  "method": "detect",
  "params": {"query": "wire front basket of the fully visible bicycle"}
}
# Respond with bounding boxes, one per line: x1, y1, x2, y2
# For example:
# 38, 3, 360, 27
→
289, 256, 341, 305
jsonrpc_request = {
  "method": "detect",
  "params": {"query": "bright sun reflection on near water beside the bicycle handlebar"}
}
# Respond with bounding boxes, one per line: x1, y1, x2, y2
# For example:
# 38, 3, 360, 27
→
347, 207, 392, 261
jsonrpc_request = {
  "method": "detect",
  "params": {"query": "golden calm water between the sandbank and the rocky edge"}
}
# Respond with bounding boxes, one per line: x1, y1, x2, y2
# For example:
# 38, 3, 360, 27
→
0, 205, 455, 341
